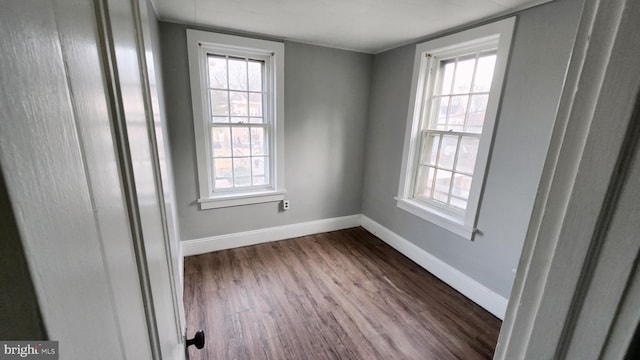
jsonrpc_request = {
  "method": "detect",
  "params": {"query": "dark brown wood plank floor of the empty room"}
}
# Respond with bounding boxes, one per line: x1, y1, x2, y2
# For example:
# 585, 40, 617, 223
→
184, 228, 501, 360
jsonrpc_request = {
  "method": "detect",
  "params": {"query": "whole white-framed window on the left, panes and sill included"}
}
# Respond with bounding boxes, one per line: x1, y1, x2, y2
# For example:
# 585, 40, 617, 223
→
187, 30, 285, 209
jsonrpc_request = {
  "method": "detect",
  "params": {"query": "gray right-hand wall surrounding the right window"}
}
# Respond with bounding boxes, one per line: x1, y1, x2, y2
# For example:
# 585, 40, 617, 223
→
363, 0, 582, 297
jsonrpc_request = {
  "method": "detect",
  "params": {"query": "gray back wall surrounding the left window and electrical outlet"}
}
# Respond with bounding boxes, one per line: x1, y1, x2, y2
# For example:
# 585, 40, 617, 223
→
160, 22, 373, 240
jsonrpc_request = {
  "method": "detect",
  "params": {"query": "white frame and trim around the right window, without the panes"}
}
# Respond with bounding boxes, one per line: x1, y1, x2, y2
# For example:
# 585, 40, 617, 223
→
396, 17, 515, 240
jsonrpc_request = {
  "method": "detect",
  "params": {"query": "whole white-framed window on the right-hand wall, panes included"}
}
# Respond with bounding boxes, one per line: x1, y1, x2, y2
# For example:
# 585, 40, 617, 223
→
397, 18, 515, 239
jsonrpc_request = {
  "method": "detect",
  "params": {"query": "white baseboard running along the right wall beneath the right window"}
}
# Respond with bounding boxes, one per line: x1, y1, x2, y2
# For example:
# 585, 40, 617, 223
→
361, 215, 509, 320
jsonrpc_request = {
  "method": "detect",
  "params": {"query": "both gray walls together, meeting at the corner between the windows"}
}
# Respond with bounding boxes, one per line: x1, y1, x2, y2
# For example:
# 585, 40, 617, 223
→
160, 0, 582, 297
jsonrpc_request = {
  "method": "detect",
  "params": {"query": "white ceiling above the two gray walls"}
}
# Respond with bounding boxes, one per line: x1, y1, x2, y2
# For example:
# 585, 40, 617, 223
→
153, 0, 552, 53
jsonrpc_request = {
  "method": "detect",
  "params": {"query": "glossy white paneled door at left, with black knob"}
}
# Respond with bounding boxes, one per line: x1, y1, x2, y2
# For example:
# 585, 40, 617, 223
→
0, 0, 184, 359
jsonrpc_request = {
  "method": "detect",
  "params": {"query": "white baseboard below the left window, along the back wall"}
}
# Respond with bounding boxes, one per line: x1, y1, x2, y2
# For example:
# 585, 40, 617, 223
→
181, 215, 362, 256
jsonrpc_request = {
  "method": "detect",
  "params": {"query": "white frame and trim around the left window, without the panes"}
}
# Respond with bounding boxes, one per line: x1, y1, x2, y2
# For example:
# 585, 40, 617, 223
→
187, 29, 286, 210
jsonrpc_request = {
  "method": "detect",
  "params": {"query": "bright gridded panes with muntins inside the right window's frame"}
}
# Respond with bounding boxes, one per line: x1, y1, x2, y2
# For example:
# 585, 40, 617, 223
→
413, 49, 496, 214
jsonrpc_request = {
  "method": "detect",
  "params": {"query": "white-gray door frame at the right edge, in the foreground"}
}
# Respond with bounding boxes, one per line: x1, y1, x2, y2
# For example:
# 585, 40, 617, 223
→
494, 0, 640, 360
